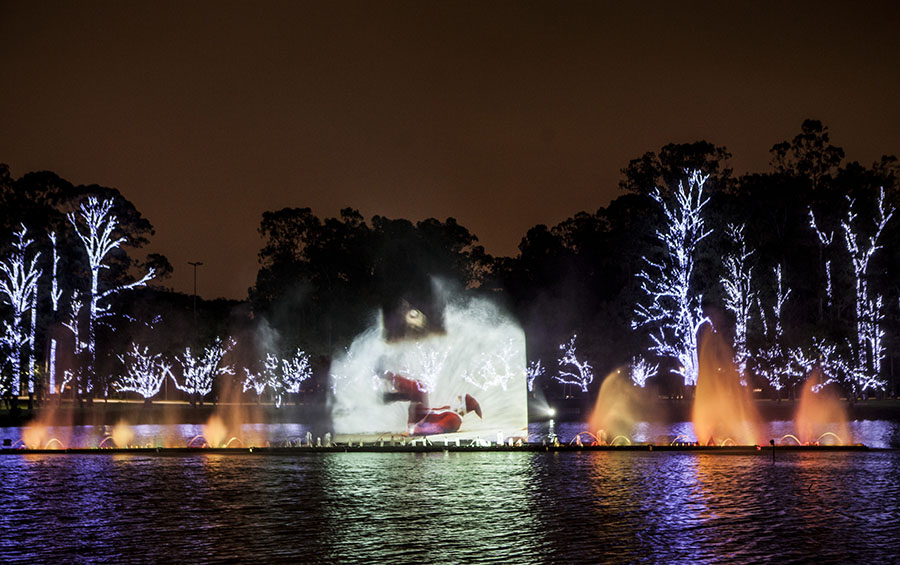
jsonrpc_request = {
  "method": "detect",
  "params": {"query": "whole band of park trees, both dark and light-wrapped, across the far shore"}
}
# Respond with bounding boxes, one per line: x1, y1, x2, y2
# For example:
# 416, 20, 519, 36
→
0, 120, 900, 404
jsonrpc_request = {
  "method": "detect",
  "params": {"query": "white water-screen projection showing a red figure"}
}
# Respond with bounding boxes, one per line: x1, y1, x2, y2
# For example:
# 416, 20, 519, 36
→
331, 286, 528, 439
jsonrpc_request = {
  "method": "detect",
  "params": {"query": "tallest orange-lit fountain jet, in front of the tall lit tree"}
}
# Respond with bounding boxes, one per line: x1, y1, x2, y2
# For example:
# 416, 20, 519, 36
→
693, 331, 760, 445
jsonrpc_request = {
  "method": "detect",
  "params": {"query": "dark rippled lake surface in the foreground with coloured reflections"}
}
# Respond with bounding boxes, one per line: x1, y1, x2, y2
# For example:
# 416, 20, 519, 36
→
0, 450, 900, 564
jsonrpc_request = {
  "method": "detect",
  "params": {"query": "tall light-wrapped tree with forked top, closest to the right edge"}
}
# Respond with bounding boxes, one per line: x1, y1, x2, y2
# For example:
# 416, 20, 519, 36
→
841, 188, 894, 396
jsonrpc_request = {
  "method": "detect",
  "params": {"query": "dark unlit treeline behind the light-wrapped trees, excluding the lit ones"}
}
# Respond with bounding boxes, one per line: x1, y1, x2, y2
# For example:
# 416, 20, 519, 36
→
0, 120, 900, 396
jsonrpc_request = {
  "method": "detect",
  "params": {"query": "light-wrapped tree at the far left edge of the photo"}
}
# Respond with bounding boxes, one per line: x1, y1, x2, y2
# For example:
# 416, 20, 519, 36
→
0, 225, 41, 395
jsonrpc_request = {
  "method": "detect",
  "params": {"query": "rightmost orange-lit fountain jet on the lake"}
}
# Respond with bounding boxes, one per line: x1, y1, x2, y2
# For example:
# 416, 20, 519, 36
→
794, 369, 851, 444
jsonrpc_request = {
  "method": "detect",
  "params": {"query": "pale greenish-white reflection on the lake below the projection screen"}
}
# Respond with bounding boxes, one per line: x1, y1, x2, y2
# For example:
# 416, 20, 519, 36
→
323, 453, 540, 563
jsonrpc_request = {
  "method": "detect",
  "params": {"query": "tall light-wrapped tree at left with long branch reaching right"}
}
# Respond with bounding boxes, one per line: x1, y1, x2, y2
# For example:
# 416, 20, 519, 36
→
68, 196, 155, 398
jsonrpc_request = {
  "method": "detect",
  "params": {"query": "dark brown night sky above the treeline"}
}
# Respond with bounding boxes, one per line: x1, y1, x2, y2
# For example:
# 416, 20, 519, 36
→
0, 0, 900, 298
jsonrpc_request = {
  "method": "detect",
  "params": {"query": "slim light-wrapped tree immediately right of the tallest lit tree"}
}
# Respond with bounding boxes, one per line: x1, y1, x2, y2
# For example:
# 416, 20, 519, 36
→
721, 224, 756, 386
